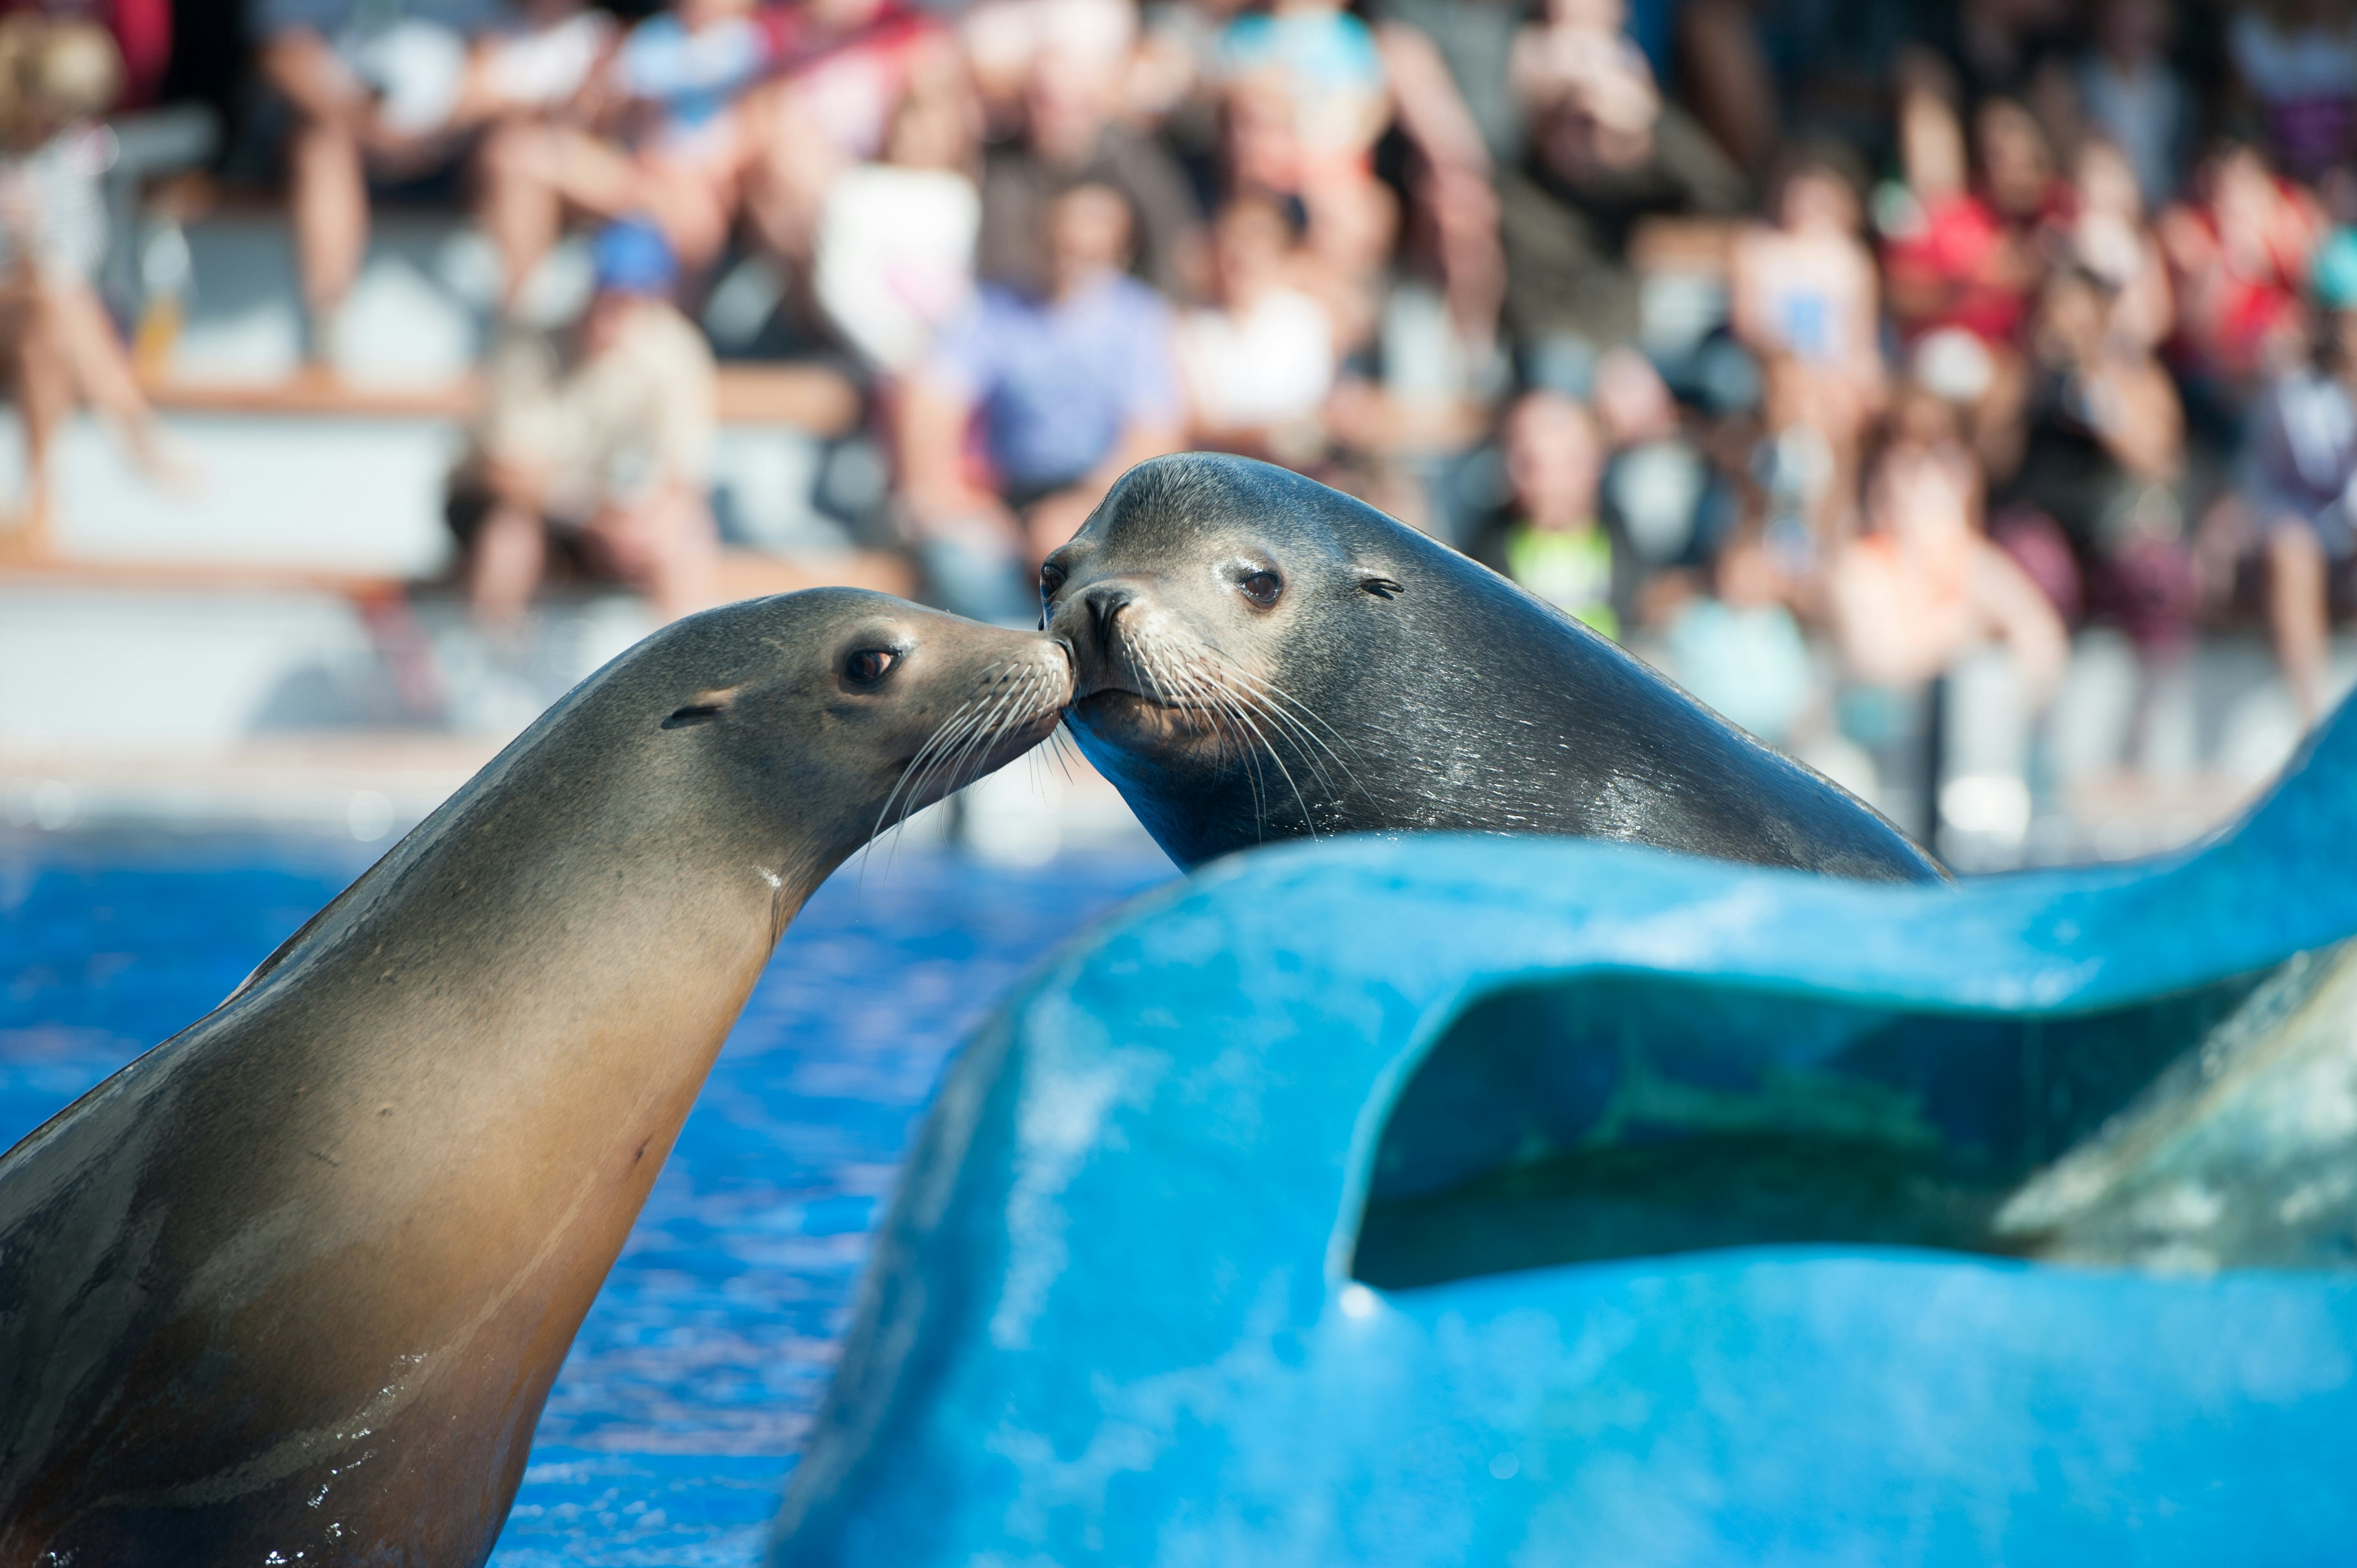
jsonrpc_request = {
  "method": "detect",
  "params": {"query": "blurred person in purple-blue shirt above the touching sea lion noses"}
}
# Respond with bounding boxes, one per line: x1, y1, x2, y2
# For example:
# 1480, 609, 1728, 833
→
900, 184, 1186, 622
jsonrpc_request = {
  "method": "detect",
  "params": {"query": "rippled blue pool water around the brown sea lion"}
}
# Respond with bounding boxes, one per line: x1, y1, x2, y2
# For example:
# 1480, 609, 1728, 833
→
0, 842, 1171, 1568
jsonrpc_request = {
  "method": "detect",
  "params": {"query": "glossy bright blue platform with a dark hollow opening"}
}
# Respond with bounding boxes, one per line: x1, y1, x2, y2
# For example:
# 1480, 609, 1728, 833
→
773, 712, 2357, 1568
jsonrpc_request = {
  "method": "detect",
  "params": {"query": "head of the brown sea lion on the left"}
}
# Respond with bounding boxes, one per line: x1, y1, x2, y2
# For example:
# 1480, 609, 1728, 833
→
617, 587, 1072, 865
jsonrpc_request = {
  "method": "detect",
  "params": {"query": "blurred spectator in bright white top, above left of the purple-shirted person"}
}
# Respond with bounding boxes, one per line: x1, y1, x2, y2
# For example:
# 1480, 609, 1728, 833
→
816, 82, 983, 375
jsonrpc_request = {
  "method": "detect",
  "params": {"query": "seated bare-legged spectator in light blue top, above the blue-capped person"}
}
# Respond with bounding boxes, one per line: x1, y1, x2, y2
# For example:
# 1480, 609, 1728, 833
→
483, 0, 773, 304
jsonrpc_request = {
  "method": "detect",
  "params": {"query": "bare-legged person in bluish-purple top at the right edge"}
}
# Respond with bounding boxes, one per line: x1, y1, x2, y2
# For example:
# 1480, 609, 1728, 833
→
2241, 229, 2357, 726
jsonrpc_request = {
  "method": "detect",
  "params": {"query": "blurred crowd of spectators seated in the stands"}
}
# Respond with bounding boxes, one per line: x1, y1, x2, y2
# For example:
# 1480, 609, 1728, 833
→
14, 0, 2357, 830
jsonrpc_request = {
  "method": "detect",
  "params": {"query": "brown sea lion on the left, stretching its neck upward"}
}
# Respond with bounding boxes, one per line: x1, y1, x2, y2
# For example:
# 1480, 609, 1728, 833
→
0, 590, 1070, 1568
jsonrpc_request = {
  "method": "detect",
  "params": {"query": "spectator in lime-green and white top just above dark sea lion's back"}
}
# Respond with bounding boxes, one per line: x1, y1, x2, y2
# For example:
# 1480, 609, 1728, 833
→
1468, 391, 1629, 637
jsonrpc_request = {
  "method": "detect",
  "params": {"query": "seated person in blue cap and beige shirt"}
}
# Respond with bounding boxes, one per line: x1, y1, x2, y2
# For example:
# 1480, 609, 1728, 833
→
448, 219, 719, 632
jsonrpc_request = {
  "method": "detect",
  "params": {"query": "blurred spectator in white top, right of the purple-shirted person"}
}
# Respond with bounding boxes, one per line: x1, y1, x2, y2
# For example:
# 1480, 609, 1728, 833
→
1179, 195, 1334, 462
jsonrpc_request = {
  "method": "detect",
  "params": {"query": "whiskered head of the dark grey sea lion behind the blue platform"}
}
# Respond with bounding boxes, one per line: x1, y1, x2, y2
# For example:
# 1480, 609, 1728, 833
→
1039, 453, 1433, 863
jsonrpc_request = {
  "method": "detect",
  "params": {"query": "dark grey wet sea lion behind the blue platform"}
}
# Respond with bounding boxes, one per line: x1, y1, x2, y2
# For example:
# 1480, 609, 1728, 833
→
1039, 453, 1942, 882
